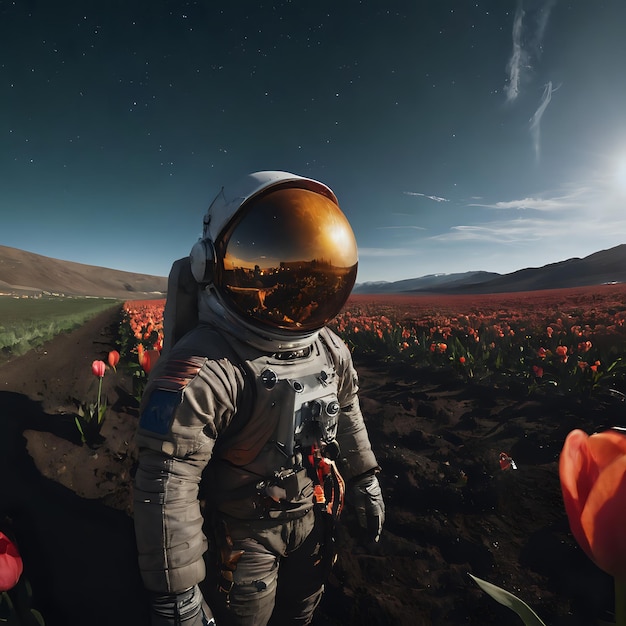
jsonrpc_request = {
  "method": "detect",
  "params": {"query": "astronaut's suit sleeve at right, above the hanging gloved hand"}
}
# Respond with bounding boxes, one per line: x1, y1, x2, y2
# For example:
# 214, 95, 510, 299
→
321, 328, 378, 481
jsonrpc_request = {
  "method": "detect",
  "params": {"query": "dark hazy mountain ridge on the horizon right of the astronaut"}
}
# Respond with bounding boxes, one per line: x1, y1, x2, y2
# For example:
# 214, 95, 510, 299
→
353, 244, 626, 294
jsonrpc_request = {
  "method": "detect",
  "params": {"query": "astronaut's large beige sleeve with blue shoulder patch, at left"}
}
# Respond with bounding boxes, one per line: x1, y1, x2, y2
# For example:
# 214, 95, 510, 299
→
133, 350, 242, 593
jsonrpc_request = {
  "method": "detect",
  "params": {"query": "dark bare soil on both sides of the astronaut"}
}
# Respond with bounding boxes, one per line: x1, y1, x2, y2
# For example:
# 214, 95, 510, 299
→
0, 310, 626, 626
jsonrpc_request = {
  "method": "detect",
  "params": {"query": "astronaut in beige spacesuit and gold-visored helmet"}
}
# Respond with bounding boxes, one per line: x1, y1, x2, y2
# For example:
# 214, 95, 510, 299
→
134, 171, 385, 626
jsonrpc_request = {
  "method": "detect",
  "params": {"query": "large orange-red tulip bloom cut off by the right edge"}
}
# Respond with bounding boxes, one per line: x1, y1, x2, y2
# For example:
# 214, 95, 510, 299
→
559, 430, 626, 580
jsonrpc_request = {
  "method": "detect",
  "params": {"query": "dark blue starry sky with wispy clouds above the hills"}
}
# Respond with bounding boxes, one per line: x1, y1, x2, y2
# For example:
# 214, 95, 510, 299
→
0, 0, 626, 282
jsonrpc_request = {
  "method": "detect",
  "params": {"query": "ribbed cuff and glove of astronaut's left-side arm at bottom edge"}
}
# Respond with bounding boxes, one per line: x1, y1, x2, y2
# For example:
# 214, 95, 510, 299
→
151, 585, 215, 626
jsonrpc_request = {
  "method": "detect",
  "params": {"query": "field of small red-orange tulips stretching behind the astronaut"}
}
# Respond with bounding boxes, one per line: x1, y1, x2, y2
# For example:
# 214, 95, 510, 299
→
120, 285, 626, 394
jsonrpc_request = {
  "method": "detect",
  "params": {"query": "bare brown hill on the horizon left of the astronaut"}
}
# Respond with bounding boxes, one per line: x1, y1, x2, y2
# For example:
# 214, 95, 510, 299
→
0, 246, 167, 299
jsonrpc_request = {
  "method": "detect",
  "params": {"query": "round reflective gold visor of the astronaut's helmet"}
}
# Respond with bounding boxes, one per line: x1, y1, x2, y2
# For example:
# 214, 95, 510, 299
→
215, 188, 358, 332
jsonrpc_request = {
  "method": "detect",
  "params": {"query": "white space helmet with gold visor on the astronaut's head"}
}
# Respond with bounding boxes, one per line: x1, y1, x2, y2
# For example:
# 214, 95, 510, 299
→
190, 171, 358, 349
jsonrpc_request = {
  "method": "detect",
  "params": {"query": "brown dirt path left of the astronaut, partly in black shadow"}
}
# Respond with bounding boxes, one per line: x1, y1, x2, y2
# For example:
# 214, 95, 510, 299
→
0, 310, 147, 626
